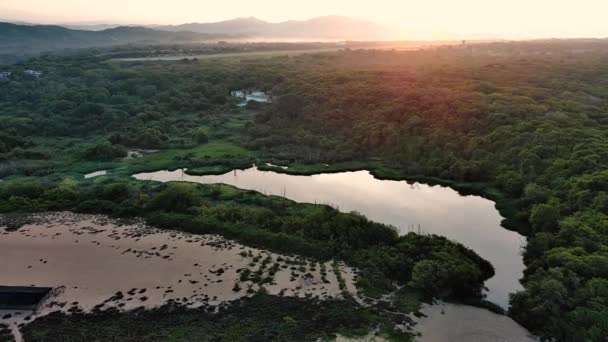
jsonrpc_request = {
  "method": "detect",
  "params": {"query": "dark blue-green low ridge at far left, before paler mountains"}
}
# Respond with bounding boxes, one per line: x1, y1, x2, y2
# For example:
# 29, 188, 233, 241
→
0, 23, 233, 54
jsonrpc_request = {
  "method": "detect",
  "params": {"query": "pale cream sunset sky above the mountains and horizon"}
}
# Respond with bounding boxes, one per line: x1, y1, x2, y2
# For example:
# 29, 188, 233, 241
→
0, 0, 608, 39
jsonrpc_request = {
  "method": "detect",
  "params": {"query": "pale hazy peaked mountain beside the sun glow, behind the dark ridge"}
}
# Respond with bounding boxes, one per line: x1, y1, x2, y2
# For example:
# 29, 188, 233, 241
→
155, 16, 396, 40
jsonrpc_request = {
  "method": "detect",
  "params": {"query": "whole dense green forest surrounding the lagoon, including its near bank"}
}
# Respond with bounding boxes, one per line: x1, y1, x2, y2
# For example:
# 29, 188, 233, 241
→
0, 40, 608, 341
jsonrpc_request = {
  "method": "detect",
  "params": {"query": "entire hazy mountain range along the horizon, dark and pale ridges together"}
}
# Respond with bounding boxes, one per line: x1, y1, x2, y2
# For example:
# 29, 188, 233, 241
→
0, 16, 396, 54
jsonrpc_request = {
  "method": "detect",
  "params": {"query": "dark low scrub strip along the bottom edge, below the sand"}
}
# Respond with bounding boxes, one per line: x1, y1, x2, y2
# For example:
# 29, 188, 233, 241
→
24, 295, 400, 342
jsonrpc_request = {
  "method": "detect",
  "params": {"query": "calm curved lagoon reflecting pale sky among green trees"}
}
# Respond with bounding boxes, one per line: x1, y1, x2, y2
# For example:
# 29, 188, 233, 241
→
134, 167, 526, 308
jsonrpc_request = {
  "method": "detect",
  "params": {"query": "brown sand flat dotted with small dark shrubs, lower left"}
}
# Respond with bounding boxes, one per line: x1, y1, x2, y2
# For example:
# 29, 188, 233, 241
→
0, 213, 356, 338
